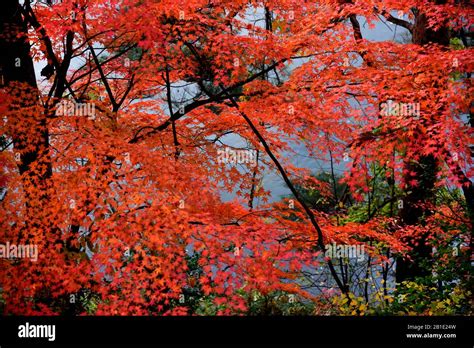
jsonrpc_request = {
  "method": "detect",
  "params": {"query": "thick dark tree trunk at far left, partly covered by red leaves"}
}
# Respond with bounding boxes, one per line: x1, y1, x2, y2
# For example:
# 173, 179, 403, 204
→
0, 0, 52, 214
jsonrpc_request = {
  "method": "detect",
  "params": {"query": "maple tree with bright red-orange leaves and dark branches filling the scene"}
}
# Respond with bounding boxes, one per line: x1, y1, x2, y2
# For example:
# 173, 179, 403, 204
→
0, 0, 474, 315
